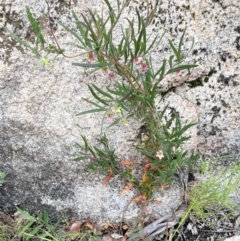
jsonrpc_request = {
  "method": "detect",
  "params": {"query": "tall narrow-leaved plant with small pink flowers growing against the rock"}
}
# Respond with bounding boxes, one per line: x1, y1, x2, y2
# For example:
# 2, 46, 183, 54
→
6, 0, 197, 200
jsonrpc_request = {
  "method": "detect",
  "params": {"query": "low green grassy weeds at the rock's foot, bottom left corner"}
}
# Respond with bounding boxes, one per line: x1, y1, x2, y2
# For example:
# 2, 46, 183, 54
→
0, 208, 101, 241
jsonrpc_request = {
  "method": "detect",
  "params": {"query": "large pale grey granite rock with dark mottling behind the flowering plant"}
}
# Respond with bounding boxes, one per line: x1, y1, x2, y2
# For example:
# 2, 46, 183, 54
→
0, 0, 240, 222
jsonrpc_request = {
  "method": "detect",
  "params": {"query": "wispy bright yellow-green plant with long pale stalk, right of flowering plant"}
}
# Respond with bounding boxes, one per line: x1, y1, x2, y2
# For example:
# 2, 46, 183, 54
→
169, 157, 240, 241
